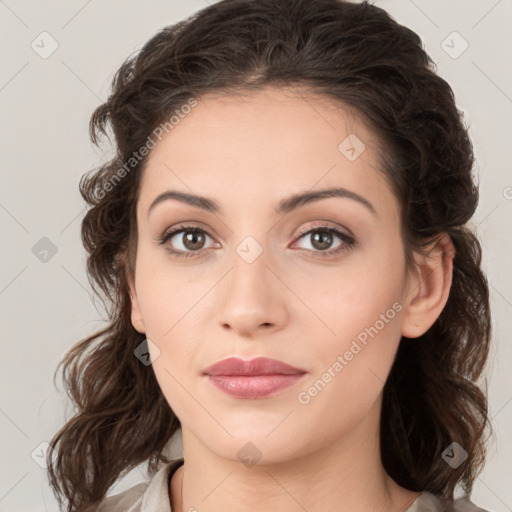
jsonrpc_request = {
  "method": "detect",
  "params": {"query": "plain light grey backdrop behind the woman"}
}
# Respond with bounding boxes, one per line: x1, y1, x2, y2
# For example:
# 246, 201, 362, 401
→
0, 0, 512, 512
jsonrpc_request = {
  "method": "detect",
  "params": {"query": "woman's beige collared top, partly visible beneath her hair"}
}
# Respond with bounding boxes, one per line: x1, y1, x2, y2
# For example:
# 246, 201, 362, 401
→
96, 458, 489, 512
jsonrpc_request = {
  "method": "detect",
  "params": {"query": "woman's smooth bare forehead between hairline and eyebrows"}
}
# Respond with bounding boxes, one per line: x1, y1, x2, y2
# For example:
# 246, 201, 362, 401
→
139, 87, 392, 220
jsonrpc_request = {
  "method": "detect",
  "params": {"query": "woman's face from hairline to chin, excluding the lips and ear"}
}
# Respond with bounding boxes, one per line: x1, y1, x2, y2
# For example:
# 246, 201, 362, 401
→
131, 88, 420, 462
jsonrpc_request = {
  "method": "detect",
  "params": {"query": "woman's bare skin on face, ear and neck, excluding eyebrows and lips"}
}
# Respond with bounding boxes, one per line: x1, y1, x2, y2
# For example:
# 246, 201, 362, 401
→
126, 88, 453, 512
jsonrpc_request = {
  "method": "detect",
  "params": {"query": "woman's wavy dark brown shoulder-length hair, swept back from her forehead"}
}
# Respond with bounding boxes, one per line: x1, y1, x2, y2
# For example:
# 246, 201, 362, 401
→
48, 0, 491, 512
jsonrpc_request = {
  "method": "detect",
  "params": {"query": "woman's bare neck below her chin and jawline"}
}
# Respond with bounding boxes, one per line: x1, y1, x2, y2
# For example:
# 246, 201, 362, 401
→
171, 400, 419, 512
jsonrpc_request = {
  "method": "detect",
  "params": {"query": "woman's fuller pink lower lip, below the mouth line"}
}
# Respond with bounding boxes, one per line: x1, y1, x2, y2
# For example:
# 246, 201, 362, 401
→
208, 373, 305, 398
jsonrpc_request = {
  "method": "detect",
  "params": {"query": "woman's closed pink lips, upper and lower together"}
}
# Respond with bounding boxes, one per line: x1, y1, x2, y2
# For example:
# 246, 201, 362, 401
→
203, 357, 307, 398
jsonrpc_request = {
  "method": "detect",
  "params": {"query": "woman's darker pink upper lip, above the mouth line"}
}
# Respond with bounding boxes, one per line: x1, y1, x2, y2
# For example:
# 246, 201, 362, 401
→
203, 357, 306, 375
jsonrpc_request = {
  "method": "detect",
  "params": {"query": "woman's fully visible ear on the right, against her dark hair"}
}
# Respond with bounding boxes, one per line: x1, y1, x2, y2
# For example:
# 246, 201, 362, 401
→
402, 233, 455, 338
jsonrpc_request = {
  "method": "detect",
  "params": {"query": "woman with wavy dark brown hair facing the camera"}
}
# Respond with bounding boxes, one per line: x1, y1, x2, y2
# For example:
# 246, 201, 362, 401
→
49, 0, 490, 512
